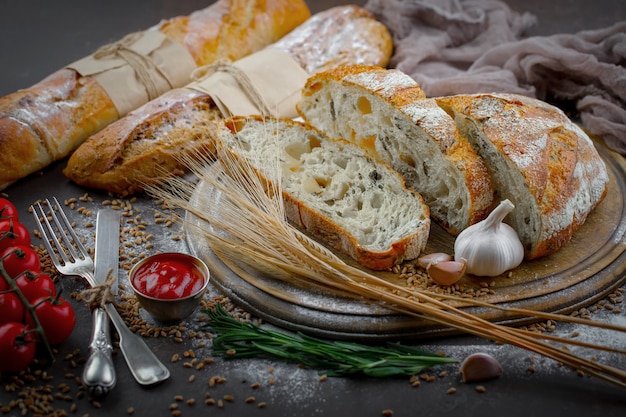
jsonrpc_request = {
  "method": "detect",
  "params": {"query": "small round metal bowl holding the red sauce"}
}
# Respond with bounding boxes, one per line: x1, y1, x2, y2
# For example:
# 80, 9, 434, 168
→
129, 252, 210, 322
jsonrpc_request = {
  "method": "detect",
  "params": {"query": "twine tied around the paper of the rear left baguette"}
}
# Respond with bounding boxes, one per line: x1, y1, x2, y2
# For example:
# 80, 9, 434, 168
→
93, 32, 174, 100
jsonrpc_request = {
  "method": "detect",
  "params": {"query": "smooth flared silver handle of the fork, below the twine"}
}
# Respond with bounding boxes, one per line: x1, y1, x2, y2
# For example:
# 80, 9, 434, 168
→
105, 303, 170, 385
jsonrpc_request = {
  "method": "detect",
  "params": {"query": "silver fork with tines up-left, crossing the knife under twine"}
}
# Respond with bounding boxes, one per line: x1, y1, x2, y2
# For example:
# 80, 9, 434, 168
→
31, 198, 170, 385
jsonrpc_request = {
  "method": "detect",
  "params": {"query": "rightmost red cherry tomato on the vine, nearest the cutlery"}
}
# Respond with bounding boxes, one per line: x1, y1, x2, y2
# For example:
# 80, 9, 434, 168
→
26, 297, 76, 345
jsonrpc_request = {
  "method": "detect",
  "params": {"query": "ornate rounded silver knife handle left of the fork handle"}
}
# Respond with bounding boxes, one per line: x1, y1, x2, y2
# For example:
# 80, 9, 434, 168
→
83, 307, 117, 396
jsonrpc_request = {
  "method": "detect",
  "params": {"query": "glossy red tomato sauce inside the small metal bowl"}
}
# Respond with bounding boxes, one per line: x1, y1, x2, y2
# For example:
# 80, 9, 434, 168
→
132, 253, 204, 300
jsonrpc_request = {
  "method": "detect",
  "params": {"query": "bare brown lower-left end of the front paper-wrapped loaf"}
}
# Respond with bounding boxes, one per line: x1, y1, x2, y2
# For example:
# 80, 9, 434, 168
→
63, 89, 219, 196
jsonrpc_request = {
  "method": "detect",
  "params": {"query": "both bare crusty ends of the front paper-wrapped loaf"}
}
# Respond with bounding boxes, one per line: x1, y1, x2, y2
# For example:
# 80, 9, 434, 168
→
63, 6, 392, 195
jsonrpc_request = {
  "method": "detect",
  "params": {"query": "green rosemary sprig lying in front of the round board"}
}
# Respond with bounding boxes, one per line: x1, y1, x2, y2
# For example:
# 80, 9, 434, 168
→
203, 303, 457, 377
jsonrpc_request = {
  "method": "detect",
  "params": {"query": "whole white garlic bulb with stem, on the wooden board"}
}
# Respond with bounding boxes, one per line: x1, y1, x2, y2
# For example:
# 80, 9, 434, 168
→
454, 200, 524, 277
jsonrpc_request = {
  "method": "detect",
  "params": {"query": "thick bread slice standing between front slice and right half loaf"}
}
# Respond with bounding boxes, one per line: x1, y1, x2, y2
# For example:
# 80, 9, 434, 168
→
298, 65, 493, 234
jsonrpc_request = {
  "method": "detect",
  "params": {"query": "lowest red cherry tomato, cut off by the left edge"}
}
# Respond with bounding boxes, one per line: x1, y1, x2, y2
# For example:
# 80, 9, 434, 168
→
0, 322, 36, 372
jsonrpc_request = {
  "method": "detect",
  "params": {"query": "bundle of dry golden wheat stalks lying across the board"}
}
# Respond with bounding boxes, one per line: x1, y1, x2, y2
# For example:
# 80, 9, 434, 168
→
148, 120, 626, 388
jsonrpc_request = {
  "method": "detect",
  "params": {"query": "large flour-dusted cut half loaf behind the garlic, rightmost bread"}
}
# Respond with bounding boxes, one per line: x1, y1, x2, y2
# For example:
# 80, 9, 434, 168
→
437, 94, 609, 259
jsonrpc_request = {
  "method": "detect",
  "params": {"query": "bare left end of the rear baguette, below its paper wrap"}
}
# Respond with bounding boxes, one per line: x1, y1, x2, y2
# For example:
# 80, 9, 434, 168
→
0, 69, 119, 189
